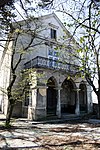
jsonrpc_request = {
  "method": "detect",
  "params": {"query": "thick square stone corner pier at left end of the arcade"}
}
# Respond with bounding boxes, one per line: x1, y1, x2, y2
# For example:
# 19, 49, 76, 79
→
28, 86, 47, 120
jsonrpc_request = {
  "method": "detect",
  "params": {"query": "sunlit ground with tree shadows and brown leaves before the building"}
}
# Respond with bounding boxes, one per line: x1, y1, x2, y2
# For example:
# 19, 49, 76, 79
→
0, 115, 100, 150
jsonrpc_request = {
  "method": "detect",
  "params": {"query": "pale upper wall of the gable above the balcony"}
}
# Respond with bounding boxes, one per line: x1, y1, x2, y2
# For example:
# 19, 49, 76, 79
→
16, 14, 77, 68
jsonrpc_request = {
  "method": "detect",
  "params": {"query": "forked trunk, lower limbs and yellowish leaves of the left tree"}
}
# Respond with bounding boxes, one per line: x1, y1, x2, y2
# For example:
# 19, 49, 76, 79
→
6, 29, 35, 126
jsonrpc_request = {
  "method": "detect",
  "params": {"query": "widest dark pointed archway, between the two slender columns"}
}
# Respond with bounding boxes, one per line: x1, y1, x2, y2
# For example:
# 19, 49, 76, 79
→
61, 78, 76, 114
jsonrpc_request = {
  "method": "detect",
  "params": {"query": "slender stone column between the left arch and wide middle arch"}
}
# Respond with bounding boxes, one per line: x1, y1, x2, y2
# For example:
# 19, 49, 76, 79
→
56, 87, 61, 118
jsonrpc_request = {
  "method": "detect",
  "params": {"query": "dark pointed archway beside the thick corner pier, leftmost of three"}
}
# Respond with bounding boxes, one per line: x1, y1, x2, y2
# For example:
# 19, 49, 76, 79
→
46, 76, 57, 115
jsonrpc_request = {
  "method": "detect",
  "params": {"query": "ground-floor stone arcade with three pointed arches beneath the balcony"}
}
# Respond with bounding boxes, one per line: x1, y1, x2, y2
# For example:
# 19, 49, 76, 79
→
22, 69, 92, 120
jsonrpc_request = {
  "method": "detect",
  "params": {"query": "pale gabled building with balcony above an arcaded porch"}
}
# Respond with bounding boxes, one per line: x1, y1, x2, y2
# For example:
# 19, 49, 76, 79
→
0, 14, 92, 120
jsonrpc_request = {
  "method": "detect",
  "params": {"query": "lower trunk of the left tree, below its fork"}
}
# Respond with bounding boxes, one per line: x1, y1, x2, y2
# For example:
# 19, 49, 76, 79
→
6, 102, 14, 126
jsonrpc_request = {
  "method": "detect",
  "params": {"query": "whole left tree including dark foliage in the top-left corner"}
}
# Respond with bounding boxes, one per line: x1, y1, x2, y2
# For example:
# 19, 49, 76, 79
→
0, 0, 42, 126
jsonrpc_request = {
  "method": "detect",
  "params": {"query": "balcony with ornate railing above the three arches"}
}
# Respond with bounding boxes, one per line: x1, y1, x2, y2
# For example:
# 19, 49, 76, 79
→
24, 56, 78, 74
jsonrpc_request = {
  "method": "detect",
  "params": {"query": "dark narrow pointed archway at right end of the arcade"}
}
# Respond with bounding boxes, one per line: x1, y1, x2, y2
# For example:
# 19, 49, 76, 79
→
79, 81, 87, 113
